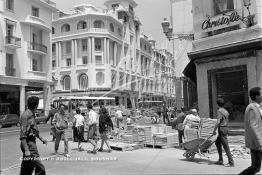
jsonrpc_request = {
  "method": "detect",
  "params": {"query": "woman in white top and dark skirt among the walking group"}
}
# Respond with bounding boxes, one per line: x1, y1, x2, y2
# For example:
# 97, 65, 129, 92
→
73, 108, 85, 151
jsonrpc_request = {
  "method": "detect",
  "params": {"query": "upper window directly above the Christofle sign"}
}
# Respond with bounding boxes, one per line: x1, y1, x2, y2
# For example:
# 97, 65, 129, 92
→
214, 0, 234, 15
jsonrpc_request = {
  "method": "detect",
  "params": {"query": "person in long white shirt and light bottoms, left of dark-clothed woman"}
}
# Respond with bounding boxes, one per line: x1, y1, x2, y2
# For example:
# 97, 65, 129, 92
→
87, 104, 99, 154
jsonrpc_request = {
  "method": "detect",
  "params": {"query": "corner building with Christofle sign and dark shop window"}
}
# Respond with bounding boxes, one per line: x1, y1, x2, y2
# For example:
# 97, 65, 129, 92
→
185, 0, 262, 125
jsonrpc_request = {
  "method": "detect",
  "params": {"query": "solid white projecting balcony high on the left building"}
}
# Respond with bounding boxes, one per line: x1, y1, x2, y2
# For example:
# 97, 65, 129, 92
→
21, 15, 51, 33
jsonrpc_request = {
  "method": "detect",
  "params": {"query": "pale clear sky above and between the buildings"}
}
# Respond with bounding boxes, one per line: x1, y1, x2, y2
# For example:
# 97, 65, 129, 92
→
52, 0, 172, 51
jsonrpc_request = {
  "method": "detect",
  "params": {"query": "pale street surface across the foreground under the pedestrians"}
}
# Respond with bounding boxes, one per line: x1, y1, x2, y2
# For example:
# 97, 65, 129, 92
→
0, 125, 258, 175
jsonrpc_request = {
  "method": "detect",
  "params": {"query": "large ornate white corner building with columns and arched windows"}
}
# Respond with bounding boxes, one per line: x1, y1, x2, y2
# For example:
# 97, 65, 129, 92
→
52, 0, 176, 108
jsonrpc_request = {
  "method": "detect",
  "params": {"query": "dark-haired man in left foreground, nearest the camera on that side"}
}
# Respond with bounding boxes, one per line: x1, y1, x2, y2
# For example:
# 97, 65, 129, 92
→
20, 96, 47, 175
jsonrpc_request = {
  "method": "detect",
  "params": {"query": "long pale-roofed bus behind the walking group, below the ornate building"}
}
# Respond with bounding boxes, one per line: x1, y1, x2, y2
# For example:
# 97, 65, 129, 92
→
53, 96, 116, 114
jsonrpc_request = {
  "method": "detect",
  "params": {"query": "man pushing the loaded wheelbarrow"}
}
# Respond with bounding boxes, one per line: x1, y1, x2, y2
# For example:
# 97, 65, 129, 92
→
213, 98, 234, 167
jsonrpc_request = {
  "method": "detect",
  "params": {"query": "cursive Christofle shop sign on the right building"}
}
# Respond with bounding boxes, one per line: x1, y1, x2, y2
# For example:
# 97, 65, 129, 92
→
201, 11, 248, 30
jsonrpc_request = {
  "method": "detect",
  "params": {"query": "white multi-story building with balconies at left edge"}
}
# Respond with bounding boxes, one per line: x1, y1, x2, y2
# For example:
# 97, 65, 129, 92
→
0, 0, 56, 114
